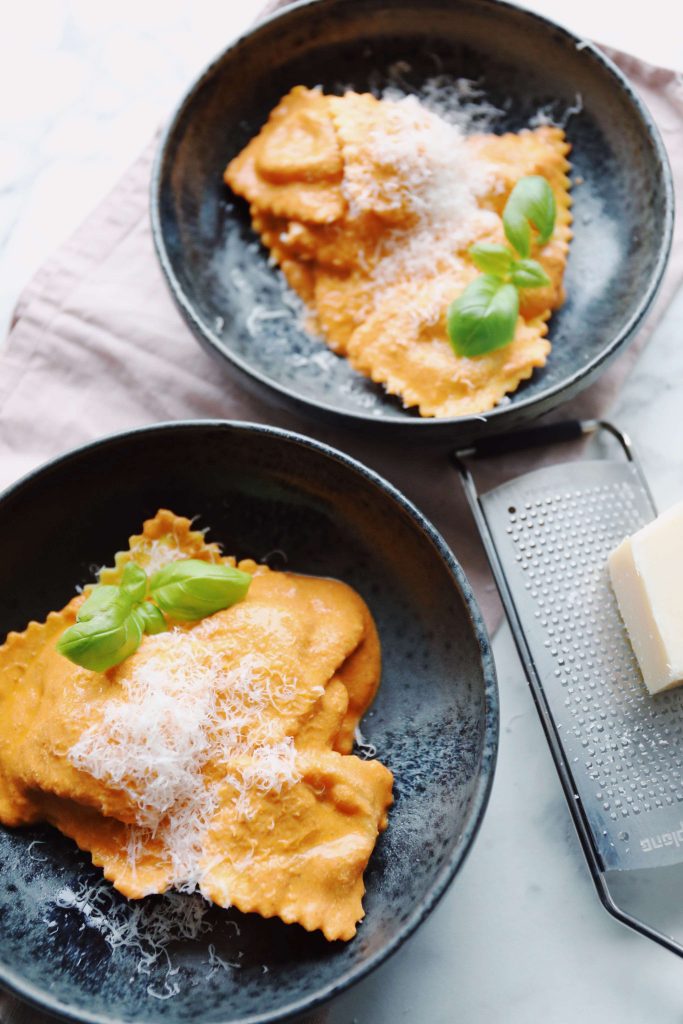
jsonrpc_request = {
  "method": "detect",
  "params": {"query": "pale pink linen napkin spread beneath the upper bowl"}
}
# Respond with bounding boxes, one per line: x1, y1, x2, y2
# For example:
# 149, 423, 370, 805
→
0, 19, 683, 1024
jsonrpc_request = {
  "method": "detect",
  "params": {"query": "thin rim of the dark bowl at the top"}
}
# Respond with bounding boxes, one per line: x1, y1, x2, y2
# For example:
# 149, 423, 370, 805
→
150, 0, 675, 439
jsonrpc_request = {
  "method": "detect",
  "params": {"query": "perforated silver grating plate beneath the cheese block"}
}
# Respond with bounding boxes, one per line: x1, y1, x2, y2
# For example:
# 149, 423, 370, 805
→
480, 460, 683, 868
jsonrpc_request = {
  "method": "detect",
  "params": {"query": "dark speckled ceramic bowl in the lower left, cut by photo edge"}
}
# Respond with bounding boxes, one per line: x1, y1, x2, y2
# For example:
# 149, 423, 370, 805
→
0, 422, 498, 1024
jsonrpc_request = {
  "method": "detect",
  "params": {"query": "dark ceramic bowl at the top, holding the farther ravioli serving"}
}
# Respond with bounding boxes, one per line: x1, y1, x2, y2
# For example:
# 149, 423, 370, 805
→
152, 0, 673, 442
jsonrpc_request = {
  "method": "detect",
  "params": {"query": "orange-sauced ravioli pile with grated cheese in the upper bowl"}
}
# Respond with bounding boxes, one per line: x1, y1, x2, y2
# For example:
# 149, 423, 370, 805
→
224, 86, 571, 417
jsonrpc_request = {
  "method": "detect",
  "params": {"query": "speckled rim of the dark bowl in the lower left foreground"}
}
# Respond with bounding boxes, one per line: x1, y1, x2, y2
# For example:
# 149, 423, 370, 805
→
0, 419, 500, 1024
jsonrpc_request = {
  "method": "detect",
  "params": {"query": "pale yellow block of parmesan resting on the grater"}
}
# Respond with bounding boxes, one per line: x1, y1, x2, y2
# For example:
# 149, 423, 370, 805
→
608, 503, 683, 693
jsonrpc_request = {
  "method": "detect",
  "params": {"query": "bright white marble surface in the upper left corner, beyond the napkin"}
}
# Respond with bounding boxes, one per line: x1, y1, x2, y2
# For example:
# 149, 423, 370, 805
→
0, 0, 265, 334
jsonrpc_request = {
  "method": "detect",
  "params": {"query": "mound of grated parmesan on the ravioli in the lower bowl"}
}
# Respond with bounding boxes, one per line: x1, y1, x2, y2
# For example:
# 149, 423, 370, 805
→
69, 618, 301, 892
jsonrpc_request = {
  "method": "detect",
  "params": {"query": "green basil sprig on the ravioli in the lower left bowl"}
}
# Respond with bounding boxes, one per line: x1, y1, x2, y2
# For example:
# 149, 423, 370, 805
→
57, 558, 252, 672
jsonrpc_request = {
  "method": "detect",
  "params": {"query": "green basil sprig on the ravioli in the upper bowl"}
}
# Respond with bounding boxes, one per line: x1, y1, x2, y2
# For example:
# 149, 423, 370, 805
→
446, 174, 557, 356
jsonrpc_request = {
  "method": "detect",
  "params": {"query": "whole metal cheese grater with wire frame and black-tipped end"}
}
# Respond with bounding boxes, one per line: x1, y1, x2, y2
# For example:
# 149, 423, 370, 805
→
454, 421, 683, 955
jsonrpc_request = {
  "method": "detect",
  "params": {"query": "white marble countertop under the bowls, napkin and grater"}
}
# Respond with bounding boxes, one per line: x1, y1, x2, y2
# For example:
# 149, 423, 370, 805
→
0, 0, 683, 1024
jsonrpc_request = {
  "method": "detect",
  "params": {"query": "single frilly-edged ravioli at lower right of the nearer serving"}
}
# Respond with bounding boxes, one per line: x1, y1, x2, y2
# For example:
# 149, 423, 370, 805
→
203, 751, 390, 938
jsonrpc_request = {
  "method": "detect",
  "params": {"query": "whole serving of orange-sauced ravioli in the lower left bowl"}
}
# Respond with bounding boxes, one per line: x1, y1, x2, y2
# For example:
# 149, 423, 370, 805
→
0, 510, 392, 940
